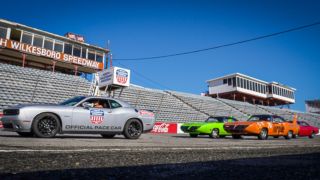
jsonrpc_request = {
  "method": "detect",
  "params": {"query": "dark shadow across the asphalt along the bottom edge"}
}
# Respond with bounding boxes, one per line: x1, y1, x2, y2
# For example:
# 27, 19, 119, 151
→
0, 153, 320, 180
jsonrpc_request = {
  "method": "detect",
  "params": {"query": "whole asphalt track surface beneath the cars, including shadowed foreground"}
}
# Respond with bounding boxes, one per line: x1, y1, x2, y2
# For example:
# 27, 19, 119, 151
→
0, 131, 320, 179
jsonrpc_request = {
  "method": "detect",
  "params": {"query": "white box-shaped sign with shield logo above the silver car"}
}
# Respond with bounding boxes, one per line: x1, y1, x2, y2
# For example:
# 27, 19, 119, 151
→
98, 67, 130, 88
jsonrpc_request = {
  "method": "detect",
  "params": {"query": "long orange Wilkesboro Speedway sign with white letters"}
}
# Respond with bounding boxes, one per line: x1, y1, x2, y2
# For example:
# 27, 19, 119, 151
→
0, 38, 103, 69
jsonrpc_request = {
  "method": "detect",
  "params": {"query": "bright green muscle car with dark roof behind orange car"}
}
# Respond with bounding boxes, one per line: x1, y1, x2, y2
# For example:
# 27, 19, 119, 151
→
181, 116, 238, 138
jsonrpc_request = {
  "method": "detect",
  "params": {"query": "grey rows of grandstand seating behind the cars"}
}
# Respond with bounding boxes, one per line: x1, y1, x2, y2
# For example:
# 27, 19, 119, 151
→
0, 63, 320, 127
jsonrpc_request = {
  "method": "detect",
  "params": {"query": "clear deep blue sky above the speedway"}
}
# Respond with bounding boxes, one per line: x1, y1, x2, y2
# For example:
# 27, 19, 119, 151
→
0, 0, 320, 111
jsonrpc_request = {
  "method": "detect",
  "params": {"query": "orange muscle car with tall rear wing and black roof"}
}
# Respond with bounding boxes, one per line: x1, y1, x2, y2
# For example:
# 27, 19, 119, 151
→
224, 115, 299, 139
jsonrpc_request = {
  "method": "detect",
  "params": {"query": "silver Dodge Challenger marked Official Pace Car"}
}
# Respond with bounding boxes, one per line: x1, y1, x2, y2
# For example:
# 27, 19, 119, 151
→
1, 96, 155, 139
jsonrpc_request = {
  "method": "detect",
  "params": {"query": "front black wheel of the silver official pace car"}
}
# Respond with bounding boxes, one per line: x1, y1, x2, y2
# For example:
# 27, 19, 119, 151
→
32, 113, 61, 138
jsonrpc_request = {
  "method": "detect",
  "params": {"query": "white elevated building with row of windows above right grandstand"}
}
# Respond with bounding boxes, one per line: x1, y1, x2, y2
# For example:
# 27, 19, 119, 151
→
207, 73, 296, 106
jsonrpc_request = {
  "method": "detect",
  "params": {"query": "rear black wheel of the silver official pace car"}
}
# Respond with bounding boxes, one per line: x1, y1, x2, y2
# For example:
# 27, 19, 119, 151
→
123, 119, 143, 139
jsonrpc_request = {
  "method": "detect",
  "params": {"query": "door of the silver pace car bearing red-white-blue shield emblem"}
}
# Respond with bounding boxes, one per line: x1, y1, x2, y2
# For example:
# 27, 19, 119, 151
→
69, 98, 116, 132
